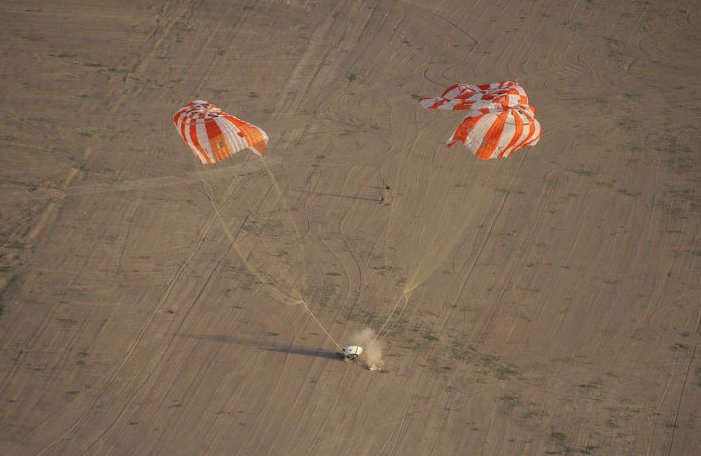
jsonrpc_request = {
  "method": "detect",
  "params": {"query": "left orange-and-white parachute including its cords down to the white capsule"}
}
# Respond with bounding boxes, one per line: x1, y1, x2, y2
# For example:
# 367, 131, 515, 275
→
173, 100, 344, 355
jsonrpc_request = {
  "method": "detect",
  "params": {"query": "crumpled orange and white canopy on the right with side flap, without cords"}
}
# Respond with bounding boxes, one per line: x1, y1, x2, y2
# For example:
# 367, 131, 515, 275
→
419, 81, 541, 160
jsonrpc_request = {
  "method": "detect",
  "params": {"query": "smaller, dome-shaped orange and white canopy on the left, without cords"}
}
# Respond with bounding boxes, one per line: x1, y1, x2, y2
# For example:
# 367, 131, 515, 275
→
173, 100, 268, 164
